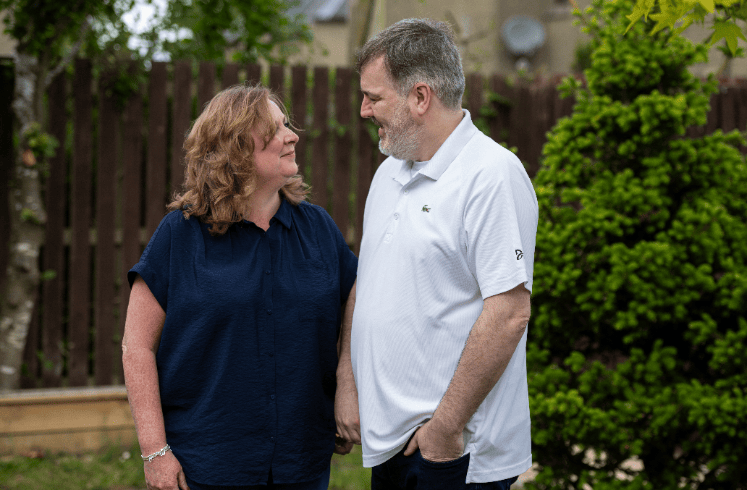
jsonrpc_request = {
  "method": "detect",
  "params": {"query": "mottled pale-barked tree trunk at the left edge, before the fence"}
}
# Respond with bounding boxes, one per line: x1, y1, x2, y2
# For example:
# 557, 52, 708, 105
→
0, 54, 46, 392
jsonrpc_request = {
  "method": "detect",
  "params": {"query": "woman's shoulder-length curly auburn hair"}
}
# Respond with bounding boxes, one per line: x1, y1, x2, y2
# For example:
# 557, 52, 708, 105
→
168, 85, 309, 235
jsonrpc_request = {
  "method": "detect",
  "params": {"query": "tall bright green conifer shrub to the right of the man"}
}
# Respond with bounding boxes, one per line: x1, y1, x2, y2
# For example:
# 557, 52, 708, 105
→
526, 0, 747, 490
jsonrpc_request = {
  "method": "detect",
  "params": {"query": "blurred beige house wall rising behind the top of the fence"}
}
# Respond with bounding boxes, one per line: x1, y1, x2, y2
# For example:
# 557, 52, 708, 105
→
304, 0, 747, 77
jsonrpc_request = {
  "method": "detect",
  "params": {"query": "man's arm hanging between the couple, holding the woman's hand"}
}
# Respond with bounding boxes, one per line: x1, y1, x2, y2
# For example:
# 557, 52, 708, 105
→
335, 281, 361, 448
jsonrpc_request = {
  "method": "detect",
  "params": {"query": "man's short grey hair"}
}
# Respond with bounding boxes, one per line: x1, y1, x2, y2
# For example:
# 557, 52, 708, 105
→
356, 19, 464, 109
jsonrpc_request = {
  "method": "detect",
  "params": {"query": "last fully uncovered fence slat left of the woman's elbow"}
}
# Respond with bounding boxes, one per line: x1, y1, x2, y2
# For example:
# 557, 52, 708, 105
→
94, 73, 119, 386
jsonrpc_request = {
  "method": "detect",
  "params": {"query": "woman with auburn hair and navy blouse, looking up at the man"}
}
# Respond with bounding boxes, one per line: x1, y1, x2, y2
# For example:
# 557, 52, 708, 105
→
123, 86, 357, 490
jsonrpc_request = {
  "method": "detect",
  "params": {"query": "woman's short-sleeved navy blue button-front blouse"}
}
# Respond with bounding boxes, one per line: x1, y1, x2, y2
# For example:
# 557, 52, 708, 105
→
128, 199, 358, 486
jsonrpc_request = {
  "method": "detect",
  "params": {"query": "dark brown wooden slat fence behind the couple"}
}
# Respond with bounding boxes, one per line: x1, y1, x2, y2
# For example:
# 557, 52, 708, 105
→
5, 59, 747, 387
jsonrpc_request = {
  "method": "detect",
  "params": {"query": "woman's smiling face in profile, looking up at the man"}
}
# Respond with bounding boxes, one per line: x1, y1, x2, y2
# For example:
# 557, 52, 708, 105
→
252, 101, 298, 189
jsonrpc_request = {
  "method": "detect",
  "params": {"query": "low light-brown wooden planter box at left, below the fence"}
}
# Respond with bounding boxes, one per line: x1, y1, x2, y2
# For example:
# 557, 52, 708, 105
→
0, 386, 137, 455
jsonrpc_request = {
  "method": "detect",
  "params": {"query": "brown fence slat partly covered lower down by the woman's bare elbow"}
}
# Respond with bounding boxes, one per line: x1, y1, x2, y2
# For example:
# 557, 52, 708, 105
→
117, 85, 143, 382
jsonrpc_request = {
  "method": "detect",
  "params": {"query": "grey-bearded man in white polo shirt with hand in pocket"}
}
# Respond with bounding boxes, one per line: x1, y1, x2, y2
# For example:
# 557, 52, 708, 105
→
335, 19, 538, 490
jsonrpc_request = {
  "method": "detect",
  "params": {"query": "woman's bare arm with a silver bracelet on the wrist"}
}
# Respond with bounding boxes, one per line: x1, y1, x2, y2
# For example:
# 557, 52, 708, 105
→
122, 276, 189, 490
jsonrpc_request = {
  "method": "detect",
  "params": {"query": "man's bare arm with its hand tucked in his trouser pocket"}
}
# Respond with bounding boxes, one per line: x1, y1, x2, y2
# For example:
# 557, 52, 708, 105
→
405, 284, 531, 462
